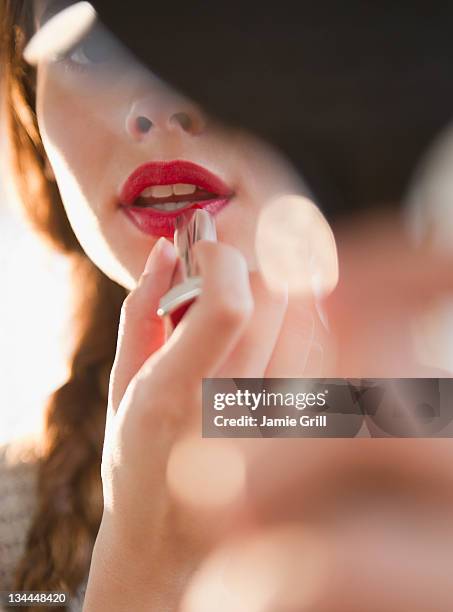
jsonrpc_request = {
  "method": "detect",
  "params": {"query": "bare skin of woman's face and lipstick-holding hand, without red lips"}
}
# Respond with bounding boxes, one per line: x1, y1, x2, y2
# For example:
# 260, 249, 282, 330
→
30, 2, 328, 612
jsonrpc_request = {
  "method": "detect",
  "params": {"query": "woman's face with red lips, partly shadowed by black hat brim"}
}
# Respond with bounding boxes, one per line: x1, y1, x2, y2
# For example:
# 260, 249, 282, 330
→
31, 0, 303, 289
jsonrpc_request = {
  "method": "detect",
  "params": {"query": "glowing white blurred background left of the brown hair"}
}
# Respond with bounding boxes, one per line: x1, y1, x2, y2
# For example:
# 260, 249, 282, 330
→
0, 114, 70, 444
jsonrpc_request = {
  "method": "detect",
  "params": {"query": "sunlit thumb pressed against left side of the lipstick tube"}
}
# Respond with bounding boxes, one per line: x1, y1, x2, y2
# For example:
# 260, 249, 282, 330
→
109, 238, 176, 412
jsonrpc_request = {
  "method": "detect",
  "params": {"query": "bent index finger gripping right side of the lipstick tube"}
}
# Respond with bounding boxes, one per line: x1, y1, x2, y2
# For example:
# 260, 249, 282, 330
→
108, 241, 253, 473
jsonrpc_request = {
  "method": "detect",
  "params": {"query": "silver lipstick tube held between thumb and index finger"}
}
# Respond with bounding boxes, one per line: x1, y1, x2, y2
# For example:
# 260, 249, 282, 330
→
157, 208, 217, 337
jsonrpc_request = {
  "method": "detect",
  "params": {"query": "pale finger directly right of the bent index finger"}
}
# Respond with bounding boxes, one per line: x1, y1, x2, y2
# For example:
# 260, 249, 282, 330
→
215, 272, 287, 378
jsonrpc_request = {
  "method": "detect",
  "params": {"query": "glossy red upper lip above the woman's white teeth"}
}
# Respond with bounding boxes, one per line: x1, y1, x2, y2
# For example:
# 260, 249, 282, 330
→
120, 160, 232, 206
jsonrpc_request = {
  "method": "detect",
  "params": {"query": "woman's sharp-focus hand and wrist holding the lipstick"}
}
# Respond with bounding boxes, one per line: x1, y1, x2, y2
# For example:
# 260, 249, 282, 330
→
85, 241, 285, 612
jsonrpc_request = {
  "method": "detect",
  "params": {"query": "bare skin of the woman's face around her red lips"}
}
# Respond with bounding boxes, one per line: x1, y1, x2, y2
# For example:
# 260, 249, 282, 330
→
37, 2, 314, 289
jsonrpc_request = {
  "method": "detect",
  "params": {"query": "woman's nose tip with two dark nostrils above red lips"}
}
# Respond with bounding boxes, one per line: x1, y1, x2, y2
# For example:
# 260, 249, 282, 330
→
126, 91, 206, 141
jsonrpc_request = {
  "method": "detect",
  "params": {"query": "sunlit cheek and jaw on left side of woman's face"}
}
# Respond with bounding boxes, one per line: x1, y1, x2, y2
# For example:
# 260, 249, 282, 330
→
37, 68, 141, 288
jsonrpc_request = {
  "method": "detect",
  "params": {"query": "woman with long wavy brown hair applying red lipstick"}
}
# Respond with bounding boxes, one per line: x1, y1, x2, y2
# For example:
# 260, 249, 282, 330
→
1, 0, 335, 609
